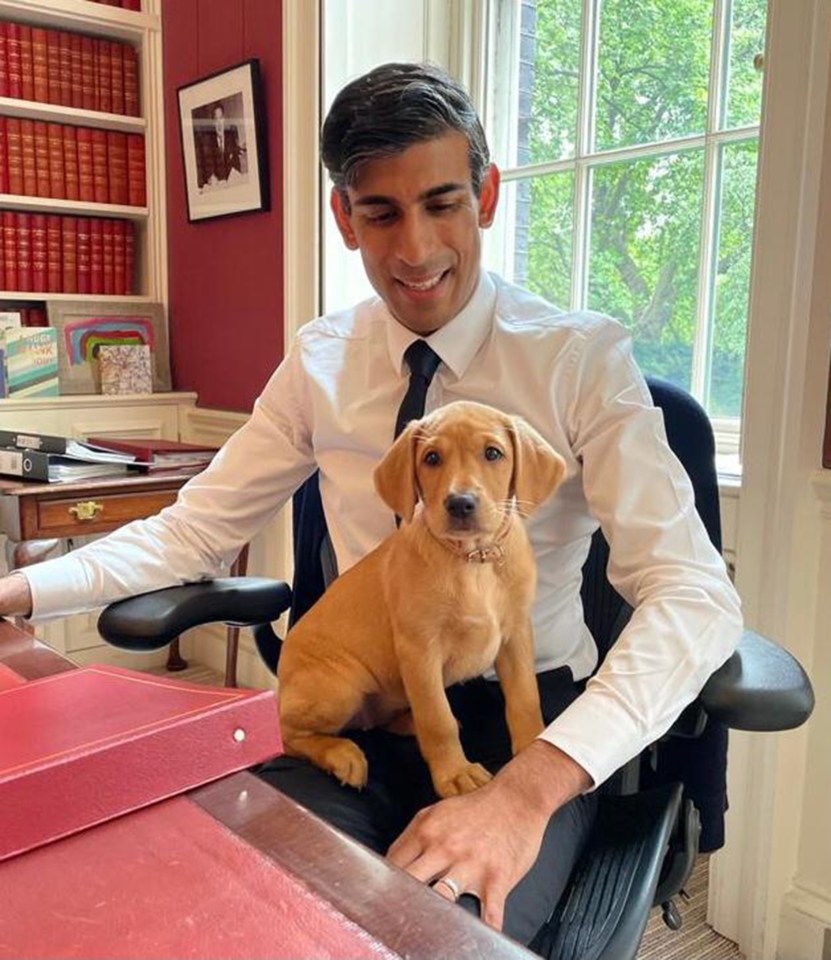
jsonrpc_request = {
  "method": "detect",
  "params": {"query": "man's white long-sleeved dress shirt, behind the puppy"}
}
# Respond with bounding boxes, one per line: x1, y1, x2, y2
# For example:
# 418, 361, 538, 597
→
22, 273, 741, 784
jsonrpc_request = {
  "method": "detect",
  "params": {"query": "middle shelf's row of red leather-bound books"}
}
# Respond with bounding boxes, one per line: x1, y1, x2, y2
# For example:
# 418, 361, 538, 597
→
0, 116, 147, 207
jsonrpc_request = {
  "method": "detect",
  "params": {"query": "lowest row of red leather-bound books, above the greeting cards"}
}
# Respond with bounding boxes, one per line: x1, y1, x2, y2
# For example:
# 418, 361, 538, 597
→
0, 210, 136, 296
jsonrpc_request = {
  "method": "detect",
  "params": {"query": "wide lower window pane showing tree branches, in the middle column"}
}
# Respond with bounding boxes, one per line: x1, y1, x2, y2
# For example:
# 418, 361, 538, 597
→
589, 150, 704, 389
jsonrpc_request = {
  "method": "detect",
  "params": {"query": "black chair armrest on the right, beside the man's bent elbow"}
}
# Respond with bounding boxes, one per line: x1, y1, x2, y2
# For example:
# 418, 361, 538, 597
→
700, 630, 814, 730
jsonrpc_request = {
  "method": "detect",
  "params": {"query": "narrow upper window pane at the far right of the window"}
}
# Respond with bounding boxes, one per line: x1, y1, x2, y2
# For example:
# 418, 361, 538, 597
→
726, 0, 767, 127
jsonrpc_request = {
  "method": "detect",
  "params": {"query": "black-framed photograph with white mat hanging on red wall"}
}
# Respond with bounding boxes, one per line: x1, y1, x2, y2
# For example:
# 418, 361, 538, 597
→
178, 59, 270, 223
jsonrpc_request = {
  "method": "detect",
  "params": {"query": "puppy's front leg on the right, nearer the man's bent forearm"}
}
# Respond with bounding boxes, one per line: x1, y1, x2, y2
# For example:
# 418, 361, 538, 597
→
494, 617, 545, 754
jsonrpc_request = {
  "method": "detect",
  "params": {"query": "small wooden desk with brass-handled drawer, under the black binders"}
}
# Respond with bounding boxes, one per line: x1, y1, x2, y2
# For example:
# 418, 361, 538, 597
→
0, 468, 248, 686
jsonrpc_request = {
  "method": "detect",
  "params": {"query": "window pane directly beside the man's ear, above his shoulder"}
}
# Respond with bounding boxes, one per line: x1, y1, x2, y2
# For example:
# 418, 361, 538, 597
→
509, 172, 574, 309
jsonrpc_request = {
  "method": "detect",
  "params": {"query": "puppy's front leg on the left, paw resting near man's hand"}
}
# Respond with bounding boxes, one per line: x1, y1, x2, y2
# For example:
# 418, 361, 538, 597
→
396, 643, 491, 797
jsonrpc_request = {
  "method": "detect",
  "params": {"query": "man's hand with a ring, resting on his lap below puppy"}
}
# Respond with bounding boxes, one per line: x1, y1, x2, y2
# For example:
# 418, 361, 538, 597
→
387, 740, 591, 930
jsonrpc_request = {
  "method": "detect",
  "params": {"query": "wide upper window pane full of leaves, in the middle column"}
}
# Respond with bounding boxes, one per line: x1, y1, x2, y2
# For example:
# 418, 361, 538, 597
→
595, 0, 713, 150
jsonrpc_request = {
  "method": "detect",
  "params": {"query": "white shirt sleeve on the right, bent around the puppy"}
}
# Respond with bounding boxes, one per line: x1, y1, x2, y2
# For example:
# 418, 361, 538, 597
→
542, 321, 742, 786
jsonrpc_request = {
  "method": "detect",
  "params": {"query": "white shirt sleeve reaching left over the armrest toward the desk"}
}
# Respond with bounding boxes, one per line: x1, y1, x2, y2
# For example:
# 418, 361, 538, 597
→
19, 351, 314, 619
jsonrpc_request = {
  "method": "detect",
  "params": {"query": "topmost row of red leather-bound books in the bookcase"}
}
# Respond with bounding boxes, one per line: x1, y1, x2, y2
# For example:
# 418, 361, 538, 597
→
0, 20, 139, 117
